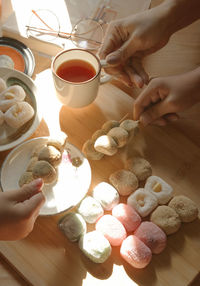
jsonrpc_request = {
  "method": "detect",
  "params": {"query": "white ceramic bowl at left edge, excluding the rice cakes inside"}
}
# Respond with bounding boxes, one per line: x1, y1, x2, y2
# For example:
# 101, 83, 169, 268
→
0, 68, 40, 152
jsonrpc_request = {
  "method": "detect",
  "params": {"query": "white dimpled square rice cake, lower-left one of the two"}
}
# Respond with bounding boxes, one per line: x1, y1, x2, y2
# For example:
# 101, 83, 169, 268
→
127, 188, 158, 217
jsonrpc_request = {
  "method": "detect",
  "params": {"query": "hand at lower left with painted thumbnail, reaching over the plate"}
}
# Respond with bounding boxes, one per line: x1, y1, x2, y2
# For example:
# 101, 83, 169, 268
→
0, 179, 45, 240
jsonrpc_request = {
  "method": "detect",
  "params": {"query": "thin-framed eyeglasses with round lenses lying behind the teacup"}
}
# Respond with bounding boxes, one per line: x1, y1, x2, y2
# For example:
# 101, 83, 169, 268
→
26, 5, 116, 50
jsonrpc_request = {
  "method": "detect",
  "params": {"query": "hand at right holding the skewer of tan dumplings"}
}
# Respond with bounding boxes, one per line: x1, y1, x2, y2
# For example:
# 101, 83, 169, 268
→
133, 68, 200, 126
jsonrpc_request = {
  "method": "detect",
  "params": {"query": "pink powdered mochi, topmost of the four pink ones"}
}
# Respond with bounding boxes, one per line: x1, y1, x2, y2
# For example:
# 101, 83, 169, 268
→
112, 203, 141, 232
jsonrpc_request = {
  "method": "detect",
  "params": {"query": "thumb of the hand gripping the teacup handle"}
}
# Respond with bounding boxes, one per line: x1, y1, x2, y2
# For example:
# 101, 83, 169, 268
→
106, 39, 136, 65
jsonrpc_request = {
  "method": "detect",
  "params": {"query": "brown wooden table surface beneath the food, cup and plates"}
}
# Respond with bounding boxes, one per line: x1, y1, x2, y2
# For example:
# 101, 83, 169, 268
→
0, 1, 200, 286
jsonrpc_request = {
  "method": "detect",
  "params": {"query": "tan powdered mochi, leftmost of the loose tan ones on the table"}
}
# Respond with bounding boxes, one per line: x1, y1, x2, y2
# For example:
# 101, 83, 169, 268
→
109, 170, 138, 196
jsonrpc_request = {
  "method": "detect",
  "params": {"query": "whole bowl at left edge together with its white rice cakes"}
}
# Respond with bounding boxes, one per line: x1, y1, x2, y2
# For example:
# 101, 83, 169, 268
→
0, 67, 40, 152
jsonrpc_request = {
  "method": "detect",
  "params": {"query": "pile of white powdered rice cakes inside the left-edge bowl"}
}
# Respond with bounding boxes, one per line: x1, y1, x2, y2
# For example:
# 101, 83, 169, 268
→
0, 78, 35, 129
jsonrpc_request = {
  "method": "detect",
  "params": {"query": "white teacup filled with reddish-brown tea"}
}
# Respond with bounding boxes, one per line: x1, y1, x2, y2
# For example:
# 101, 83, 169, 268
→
51, 49, 111, 108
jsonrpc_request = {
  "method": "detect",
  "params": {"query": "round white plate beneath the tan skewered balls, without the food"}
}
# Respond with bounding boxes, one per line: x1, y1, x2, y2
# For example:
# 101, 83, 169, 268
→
0, 137, 91, 215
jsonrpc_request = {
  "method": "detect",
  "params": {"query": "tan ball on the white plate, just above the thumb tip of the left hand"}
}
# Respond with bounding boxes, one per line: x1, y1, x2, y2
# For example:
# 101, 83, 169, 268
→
32, 160, 57, 184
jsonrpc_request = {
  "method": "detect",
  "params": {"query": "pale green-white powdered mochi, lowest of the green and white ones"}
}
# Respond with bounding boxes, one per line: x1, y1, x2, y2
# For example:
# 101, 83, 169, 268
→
79, 230, 112, 263
